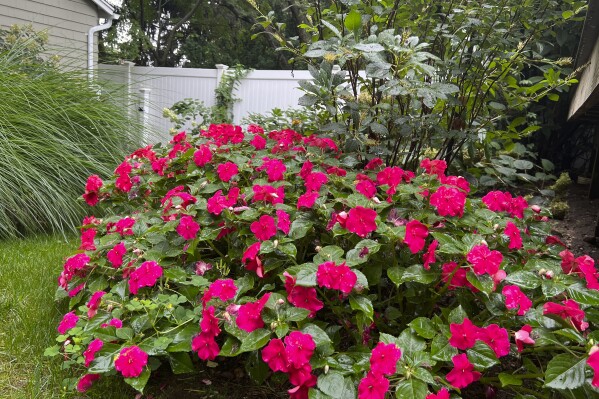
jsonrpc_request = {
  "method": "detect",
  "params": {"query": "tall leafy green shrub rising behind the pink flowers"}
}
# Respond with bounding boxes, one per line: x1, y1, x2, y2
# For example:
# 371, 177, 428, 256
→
254, 0, 586, 168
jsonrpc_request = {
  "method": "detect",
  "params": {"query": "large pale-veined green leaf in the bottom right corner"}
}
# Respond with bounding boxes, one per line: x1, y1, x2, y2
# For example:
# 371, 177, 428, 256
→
545, 353, 586, 389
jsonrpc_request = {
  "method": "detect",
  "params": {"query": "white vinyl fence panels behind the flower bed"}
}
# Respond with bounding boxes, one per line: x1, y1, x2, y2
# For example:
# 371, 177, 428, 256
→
98, 63, 312, 141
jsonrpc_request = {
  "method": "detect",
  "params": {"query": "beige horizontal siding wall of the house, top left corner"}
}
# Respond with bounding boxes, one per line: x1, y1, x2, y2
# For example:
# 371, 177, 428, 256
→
0, 0, 98, 68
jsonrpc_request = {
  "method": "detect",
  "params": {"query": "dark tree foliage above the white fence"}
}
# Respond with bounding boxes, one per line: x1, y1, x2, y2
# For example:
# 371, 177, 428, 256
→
101, 0, 303, 69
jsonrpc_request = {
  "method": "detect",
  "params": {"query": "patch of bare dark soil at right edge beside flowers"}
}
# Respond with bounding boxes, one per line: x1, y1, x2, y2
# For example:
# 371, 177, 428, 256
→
552, 183, 599, 261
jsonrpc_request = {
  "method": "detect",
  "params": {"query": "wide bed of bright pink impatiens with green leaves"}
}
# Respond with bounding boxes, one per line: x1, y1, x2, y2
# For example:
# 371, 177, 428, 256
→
47, 125, 599, 399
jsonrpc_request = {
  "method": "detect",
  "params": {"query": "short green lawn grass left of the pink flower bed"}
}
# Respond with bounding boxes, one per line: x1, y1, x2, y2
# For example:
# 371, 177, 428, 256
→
0, 236, 134, 399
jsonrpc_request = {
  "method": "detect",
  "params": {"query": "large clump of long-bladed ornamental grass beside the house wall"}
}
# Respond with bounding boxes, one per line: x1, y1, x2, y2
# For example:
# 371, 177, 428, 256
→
0, 32, 136, 241
